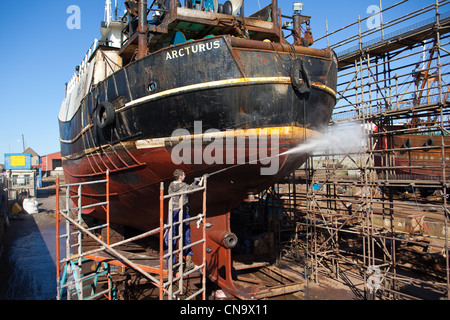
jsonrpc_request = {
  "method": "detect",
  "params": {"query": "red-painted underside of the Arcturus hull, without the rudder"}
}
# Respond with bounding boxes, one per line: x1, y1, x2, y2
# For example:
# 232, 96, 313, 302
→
61, 127, 318, 231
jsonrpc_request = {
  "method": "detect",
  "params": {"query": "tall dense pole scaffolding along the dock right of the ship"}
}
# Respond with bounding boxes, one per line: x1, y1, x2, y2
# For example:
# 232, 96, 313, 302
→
282, 1, 450, 299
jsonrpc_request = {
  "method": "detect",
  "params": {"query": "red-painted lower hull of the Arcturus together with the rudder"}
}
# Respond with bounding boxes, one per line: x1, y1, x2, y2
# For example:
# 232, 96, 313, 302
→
65, 130, 313, 298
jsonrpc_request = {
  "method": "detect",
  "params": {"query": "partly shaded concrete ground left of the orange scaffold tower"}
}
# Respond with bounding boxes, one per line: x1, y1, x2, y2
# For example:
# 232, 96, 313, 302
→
0, 194, 62, 300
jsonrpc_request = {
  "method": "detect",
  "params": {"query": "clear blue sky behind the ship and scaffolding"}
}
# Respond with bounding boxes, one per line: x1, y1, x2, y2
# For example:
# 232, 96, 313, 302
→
0, 0, 434, 163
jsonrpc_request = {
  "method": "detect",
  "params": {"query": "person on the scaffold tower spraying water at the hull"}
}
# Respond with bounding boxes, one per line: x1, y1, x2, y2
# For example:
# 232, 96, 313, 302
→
165, 169, 203, 271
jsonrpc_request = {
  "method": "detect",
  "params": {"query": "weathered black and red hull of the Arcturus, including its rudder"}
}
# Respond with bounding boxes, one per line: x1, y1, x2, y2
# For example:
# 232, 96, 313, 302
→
59, 36, 337, 298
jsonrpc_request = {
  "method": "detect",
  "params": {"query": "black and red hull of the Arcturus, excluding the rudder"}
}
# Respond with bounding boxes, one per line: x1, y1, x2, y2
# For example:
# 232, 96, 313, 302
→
60, 36, 337, 230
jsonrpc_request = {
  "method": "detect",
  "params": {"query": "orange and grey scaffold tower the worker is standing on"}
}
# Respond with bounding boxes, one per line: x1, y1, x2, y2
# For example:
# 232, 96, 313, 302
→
56, 171, 206, 300
